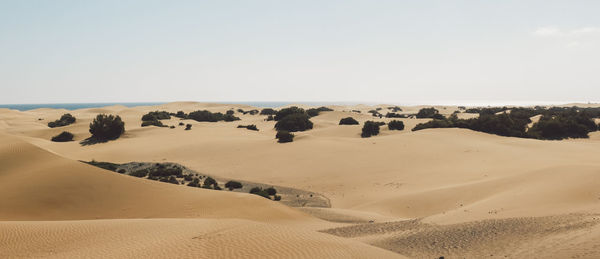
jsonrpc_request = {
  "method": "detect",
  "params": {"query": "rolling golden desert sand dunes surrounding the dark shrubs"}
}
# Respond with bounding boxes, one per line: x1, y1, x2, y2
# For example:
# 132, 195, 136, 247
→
0, 102, 600, 258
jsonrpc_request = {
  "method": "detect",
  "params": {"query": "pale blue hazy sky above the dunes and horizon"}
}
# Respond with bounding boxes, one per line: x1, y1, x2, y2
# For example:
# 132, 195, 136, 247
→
0, 0, 600, 104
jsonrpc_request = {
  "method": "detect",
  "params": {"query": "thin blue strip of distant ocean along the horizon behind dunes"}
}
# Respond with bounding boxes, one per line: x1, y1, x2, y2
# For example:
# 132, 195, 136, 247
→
0, 102, 357, 111
